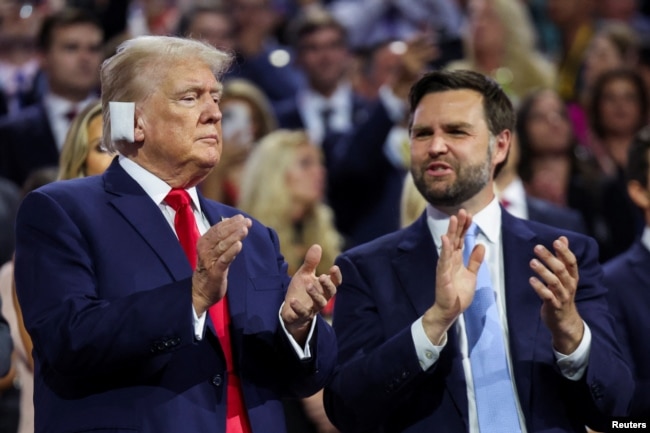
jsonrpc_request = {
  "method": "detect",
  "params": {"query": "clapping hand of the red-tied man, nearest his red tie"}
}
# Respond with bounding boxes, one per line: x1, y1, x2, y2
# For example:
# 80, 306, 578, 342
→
192, 215, 253, 317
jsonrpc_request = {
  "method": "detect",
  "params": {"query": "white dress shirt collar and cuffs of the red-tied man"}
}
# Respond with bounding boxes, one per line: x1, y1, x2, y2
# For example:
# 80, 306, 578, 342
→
119, 155, 316, 359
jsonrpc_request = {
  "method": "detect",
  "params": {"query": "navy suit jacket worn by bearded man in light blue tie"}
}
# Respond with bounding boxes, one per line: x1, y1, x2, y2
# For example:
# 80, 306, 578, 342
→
325, 212, 634, 433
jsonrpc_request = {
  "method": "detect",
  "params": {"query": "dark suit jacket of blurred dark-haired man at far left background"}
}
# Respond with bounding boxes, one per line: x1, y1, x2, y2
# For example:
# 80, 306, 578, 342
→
0, 103, 59, 187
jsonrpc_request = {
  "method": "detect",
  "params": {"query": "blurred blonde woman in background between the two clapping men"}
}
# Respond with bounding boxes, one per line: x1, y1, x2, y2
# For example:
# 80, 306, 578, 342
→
238, 130, 343, 433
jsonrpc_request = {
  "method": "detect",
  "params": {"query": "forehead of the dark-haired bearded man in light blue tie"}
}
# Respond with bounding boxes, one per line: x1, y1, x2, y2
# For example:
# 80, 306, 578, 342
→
413, 89, 485, 123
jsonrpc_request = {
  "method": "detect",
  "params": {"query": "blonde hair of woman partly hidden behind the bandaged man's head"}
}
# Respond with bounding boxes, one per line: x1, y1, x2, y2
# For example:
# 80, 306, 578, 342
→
58, 102, 107, 180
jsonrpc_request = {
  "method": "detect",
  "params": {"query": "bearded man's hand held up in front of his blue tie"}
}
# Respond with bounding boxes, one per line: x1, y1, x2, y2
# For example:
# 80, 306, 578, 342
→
422, 209, 485, 345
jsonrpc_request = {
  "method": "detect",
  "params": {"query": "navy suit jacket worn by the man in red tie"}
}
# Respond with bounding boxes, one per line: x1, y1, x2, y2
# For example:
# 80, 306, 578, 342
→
15, 160, 336, 433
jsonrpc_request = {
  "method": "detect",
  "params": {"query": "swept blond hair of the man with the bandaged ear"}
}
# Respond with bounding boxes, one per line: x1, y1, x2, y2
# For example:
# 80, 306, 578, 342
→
101, 36, 232, 151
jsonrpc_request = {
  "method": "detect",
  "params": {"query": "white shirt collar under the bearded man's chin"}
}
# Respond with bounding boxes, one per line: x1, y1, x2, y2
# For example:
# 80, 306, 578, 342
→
426, 196, 501, 249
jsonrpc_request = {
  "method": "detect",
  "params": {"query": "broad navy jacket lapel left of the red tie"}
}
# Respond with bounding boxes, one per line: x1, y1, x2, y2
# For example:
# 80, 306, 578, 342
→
103, 158, 192, 281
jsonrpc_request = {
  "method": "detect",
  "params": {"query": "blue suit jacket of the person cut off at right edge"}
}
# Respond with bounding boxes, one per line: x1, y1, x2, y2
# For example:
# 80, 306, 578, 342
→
603, 241, 650, 421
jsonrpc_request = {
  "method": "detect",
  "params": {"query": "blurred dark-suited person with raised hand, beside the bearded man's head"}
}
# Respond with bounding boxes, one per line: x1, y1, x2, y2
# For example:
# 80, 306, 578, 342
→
326, 35, 437, 245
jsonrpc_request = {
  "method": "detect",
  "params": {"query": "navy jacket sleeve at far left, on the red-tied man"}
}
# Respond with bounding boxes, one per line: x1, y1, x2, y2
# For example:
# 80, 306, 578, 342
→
15, 191, 193, 378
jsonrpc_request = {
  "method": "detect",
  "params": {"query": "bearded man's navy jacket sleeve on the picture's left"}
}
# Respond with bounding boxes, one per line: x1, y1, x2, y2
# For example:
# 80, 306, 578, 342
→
324, 254, 437, 432
